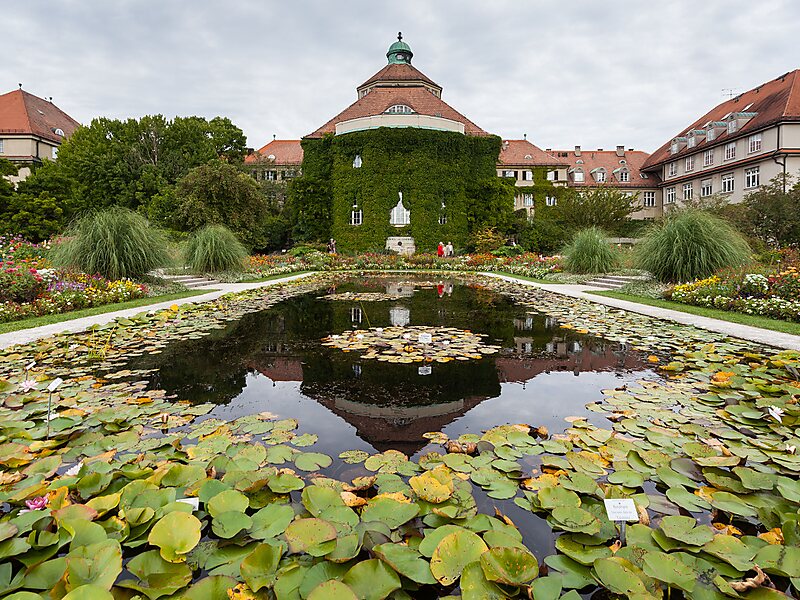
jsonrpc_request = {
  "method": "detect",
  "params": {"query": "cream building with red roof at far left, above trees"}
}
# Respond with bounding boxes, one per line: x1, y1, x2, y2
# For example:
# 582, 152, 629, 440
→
0, 88, 80, 183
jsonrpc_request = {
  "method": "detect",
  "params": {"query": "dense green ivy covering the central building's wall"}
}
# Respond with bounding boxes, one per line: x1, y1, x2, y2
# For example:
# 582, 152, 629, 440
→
292, 128, 514, 252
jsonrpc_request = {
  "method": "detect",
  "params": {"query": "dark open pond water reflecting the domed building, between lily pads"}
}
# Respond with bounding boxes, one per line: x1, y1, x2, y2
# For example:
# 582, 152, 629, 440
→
138, 276, 660, 553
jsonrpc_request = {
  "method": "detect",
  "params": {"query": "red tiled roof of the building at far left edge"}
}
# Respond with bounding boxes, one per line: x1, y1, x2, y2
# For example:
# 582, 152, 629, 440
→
0, 90, 80, 143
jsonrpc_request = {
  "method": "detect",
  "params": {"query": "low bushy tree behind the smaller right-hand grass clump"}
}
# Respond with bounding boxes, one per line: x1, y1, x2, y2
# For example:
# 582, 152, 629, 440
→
553, 187, 636, 232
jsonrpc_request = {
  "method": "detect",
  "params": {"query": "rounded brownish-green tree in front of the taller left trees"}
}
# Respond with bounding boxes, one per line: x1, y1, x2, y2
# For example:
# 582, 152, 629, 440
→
172, 160, 271, 248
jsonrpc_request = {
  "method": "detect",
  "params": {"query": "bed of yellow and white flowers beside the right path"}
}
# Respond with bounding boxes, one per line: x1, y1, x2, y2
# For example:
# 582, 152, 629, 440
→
666, 267, 800, 321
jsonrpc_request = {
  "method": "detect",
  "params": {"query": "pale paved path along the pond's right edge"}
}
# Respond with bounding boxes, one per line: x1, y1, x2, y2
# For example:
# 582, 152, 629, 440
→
482, 273, 800, 350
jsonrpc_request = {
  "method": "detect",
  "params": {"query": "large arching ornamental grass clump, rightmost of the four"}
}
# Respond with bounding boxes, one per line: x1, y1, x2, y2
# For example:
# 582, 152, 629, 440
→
636, 210, 750, 282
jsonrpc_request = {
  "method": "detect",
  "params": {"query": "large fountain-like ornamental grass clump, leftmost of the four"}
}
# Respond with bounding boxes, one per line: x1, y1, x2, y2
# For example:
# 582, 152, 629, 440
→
50, 206, 169, 279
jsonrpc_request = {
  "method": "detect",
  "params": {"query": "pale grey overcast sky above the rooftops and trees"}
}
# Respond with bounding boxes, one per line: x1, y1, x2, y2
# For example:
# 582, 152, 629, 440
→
7, 0, 800, 151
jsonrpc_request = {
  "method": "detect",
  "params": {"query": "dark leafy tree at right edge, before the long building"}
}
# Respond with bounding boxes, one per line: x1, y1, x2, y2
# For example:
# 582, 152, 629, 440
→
723, 174, 800, 247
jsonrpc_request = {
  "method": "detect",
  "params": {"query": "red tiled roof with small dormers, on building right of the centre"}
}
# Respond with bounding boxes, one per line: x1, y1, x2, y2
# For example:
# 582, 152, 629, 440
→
552, 150, 660, 188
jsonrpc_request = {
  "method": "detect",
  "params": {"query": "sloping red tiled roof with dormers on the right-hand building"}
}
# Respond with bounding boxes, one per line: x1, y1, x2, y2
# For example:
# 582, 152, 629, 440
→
644, 69, 800, 169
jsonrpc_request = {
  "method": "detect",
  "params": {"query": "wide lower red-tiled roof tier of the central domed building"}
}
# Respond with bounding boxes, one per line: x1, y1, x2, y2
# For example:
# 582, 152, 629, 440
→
306, 86, 489, 138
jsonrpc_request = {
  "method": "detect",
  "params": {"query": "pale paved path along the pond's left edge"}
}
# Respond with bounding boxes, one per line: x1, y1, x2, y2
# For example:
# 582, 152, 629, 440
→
0, 273, 311, 348
